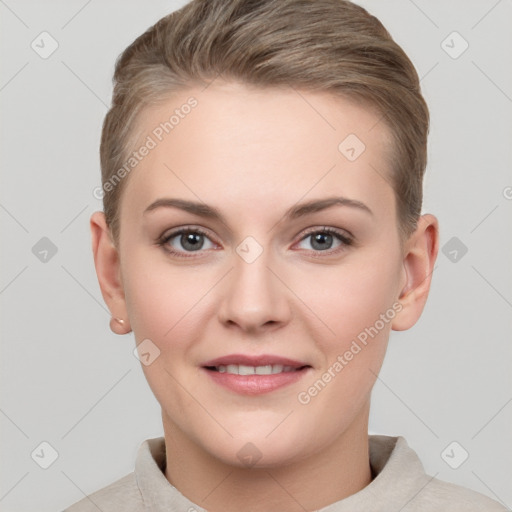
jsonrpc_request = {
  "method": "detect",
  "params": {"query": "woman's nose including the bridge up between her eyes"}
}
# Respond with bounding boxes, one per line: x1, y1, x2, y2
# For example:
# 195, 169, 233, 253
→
219, 237, 289, 330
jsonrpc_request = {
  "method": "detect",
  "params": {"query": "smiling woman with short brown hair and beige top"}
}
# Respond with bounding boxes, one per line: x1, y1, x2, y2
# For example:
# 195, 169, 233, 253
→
68, 0, 504, 512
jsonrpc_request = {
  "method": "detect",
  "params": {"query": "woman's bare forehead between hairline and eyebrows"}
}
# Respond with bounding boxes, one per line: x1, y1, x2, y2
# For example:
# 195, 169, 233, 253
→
122, 80, 393, 221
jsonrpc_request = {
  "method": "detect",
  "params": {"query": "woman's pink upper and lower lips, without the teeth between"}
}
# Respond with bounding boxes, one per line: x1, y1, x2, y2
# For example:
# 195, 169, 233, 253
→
201, 354, 312, 395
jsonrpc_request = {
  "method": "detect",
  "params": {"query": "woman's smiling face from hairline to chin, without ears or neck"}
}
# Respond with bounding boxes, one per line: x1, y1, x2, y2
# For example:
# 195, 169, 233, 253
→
113, 81, 404, 466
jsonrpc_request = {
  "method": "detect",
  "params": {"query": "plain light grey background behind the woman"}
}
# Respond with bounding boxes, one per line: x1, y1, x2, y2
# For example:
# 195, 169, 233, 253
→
0, 0, 512, 512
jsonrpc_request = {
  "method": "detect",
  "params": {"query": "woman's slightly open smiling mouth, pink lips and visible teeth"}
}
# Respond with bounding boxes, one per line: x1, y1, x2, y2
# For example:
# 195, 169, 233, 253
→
202, 354, 312, 395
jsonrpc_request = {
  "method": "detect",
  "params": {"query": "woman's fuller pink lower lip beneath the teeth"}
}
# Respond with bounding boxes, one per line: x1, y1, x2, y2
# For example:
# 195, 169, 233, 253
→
203, 368, 311, 395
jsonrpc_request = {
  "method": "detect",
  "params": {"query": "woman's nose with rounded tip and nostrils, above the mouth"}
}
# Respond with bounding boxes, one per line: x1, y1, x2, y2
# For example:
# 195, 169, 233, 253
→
218, 245, 291, 334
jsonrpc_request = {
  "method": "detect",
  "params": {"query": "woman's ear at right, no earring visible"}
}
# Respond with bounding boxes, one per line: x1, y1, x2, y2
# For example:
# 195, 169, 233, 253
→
391, 214, 439, 331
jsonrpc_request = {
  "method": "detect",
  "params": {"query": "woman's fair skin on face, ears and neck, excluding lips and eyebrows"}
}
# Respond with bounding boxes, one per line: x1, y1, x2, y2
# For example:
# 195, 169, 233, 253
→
91, 80, 438, 512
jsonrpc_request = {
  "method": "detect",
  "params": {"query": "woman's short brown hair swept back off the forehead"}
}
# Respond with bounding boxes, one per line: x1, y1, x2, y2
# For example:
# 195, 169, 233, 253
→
100, 0, 429, 243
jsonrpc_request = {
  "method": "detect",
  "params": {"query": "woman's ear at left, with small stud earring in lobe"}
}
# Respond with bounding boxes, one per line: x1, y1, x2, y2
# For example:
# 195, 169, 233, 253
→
90, 212, 131, 334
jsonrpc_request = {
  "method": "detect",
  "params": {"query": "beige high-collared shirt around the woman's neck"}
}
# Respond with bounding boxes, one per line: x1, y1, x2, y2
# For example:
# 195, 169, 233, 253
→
64, 436, 507, 512
